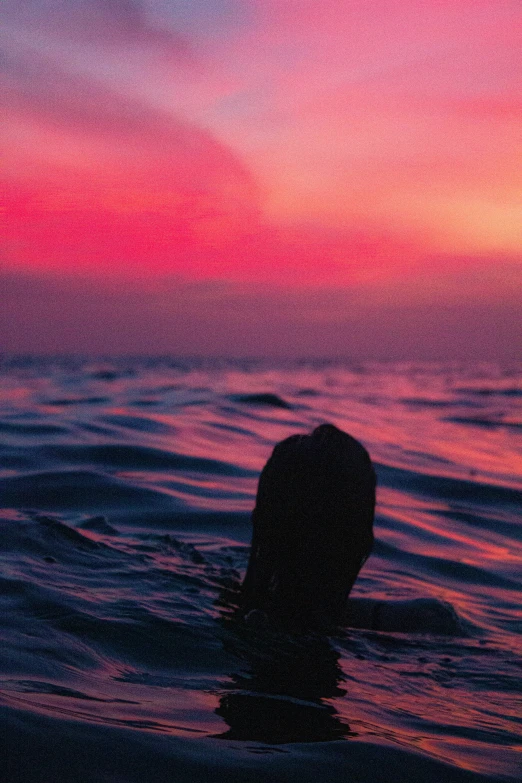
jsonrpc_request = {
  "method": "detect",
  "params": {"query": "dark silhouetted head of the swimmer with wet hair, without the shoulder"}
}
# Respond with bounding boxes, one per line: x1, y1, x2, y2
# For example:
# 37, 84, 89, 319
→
242, 424, 375, 627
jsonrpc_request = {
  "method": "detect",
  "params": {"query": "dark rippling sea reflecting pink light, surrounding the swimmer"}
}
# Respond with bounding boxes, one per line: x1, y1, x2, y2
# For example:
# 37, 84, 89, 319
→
0, 359, 522, 783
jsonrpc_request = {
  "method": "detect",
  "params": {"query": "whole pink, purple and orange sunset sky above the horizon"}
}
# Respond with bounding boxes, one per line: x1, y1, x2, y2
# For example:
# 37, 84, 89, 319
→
0, 0, 522, 359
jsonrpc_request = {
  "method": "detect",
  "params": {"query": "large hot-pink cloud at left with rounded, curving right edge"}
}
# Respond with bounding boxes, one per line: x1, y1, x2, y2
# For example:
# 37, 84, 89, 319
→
3, 40, 259, 274
